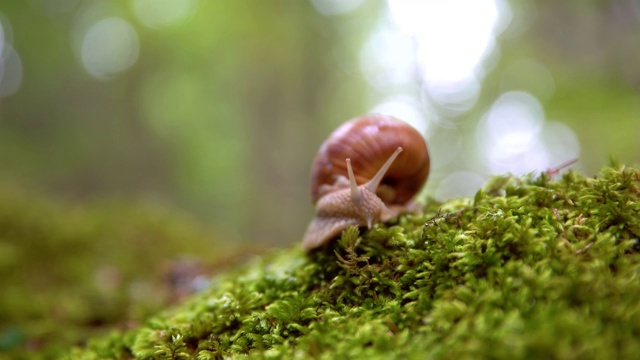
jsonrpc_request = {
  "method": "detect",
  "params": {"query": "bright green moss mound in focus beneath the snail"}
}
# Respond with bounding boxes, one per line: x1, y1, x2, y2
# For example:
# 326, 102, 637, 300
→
61, 168, 640, 359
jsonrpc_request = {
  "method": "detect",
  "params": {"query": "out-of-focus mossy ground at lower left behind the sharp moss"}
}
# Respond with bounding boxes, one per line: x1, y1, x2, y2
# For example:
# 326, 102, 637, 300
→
0, 184, 238, 359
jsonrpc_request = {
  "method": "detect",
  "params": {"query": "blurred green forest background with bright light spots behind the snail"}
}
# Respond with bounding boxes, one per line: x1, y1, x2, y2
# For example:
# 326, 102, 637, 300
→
0, 0, 640, 246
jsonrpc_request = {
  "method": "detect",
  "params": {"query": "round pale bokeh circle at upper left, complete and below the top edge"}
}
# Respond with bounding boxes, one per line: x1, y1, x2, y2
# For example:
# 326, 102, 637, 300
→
80, 17, 139, 79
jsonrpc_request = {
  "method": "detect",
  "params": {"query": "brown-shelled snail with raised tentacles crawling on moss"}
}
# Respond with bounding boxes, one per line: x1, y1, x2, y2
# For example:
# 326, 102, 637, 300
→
302, 114, 430, 251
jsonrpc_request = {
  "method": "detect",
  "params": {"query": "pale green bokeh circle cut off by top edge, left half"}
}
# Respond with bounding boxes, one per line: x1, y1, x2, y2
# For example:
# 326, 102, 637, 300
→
133, 0, 195, 28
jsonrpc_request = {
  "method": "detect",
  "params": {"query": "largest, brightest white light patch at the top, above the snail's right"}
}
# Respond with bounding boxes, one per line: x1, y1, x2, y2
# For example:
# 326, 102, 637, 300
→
387, 0, 508, 116
